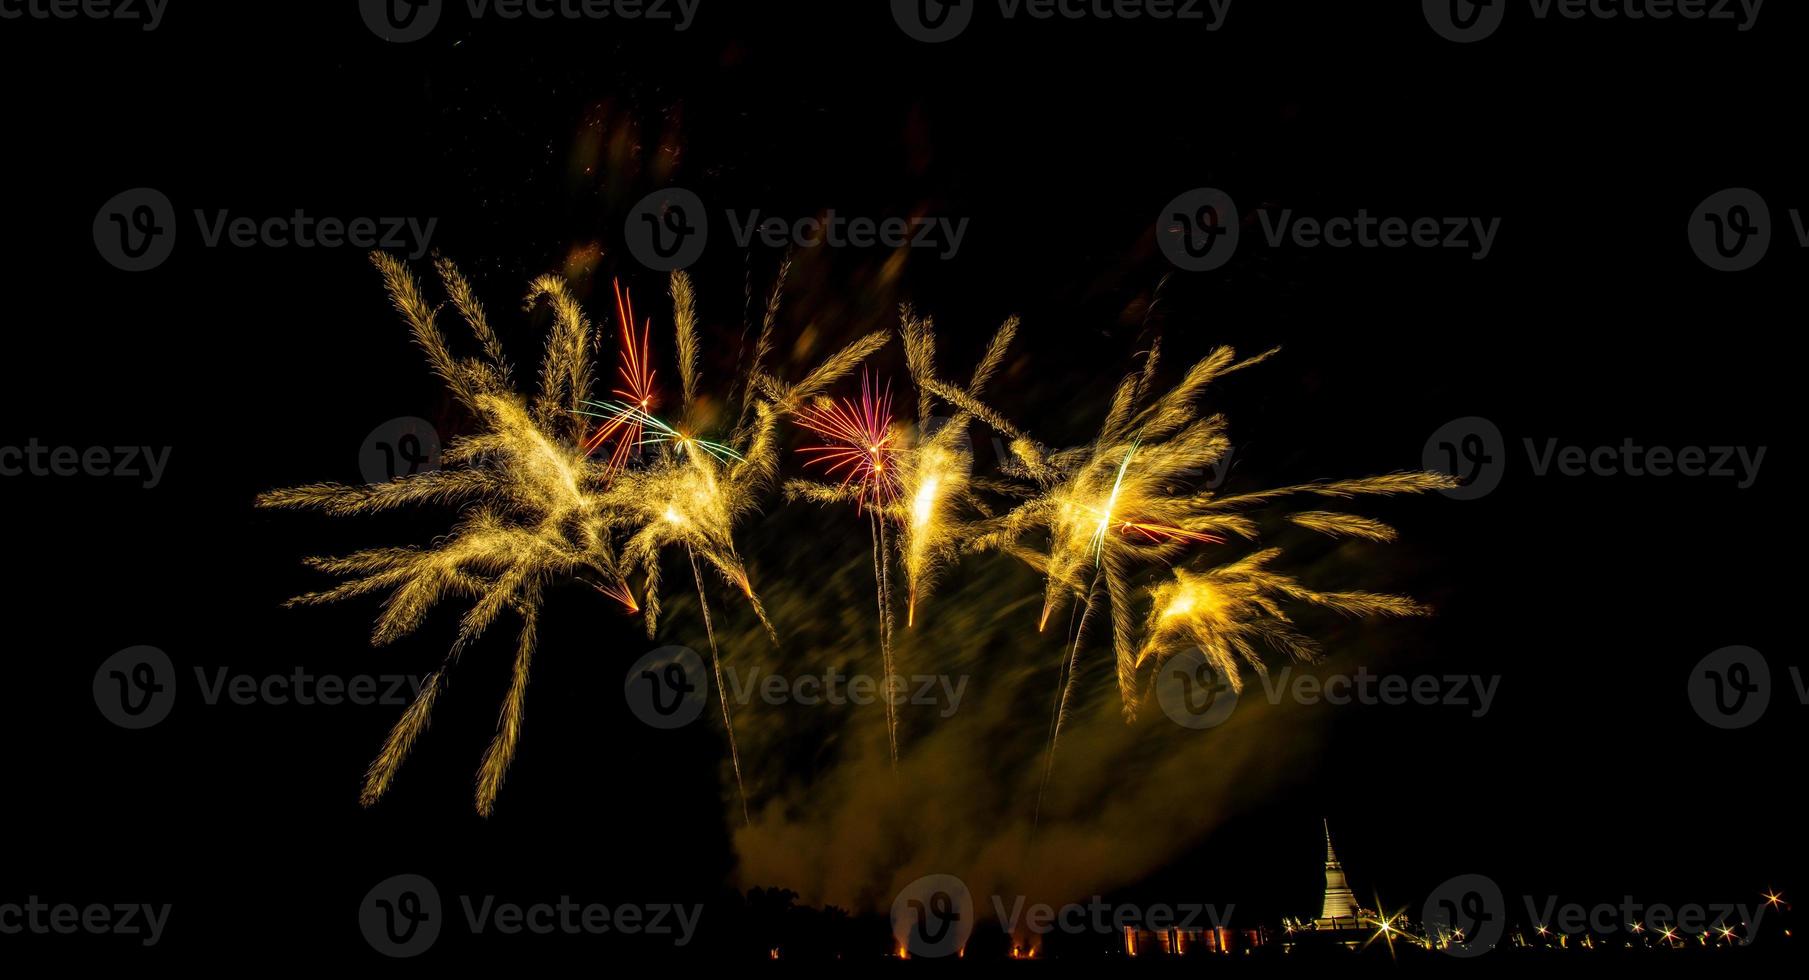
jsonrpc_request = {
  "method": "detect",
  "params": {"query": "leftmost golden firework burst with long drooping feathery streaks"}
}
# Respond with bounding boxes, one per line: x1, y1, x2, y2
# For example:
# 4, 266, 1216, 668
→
257, 253, 635, 814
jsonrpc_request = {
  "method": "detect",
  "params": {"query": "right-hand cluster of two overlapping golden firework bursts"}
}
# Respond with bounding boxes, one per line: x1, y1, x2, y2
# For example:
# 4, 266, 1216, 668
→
933, 338, 1451, 820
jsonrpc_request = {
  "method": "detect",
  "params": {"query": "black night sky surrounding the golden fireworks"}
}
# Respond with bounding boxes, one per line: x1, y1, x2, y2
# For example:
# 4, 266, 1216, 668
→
0, 0, 1809, 966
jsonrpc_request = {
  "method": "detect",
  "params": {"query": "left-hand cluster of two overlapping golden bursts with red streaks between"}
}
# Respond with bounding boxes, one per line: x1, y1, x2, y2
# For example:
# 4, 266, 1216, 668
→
257, 253, 885, 819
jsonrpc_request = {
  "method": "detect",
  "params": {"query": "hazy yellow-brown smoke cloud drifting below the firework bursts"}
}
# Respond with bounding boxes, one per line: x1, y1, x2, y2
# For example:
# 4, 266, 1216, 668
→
668, 517, 1315, 911
